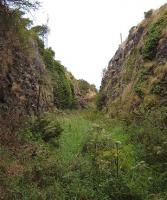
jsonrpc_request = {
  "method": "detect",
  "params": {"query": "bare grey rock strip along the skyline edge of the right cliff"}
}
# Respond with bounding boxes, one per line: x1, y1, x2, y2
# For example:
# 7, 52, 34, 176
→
101, 26, 144, 103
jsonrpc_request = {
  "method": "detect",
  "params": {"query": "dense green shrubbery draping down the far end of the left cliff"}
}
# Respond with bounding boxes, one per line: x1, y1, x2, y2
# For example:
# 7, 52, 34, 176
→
37, 45, 75, 109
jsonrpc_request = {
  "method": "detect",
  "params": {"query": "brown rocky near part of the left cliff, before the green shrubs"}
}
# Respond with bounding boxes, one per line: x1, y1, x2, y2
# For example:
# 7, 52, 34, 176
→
0, 6, 52, 128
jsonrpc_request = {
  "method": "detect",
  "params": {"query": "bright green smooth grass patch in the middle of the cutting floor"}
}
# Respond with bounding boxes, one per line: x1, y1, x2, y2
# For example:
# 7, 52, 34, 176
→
57, 112, 92, 164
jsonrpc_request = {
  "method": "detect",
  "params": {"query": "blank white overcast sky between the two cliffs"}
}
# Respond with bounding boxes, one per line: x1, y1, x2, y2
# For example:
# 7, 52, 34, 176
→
33, 0, 167, 88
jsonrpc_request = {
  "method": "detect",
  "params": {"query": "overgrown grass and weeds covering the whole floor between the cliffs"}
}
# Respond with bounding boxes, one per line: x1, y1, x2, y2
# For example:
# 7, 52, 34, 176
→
0, 110, 167, 200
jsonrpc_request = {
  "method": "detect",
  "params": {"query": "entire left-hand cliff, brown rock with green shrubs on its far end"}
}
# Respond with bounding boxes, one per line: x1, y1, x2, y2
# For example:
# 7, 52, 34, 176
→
0, 4, 94, 130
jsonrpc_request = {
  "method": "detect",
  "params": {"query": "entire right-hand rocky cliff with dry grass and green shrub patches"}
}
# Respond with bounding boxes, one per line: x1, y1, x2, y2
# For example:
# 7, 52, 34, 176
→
99, 5, 167, 120
